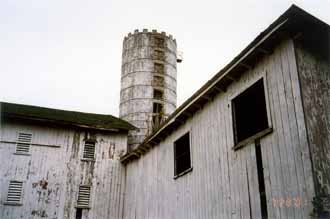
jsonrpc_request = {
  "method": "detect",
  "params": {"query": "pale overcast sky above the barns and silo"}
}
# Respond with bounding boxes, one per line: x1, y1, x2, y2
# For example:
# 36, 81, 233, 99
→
0, 0, 330, 116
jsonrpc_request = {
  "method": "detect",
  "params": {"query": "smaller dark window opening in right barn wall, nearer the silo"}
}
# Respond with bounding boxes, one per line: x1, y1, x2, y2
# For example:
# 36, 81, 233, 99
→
174, 132, 191, 176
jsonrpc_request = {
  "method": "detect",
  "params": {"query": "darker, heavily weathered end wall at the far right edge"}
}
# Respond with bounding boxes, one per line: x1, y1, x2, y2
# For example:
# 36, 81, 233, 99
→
295, 40, 330, 213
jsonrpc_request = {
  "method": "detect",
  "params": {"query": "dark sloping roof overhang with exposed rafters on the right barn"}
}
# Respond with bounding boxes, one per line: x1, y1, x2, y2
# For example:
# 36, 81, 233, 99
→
121, 5, 329, 163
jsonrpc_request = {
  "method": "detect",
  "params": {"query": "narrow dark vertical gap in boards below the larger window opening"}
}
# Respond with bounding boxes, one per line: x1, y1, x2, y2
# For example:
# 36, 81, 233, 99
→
255, 140, 268, 219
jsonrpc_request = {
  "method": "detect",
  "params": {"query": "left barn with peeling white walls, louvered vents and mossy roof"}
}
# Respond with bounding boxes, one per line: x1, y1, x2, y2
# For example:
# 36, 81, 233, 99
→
0, 103, 134, 219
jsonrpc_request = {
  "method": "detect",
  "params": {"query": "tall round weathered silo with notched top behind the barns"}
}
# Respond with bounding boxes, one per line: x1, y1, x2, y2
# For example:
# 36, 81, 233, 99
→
119, 29, 177, 149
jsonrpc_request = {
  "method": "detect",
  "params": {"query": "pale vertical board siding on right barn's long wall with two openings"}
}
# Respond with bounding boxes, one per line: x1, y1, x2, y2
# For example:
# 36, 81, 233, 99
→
124, 39, 314, 219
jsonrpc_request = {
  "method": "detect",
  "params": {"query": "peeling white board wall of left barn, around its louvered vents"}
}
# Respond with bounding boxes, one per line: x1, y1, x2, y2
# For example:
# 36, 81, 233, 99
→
0, 120, 127, 219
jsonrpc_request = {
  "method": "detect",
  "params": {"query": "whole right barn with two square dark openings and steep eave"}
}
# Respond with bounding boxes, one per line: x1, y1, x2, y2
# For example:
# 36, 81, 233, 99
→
121, 6, 330, 219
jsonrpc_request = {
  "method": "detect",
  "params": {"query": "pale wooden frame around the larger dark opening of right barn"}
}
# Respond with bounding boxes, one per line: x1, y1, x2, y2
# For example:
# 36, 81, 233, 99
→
228, 74, 273, 150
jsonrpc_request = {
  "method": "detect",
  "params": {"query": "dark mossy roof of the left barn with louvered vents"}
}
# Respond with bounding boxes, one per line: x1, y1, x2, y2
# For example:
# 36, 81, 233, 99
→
0, 102, 135, 131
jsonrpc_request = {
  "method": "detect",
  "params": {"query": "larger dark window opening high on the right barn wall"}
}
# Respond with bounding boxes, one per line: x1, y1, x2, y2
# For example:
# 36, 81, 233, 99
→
232, 79, 268, 144
